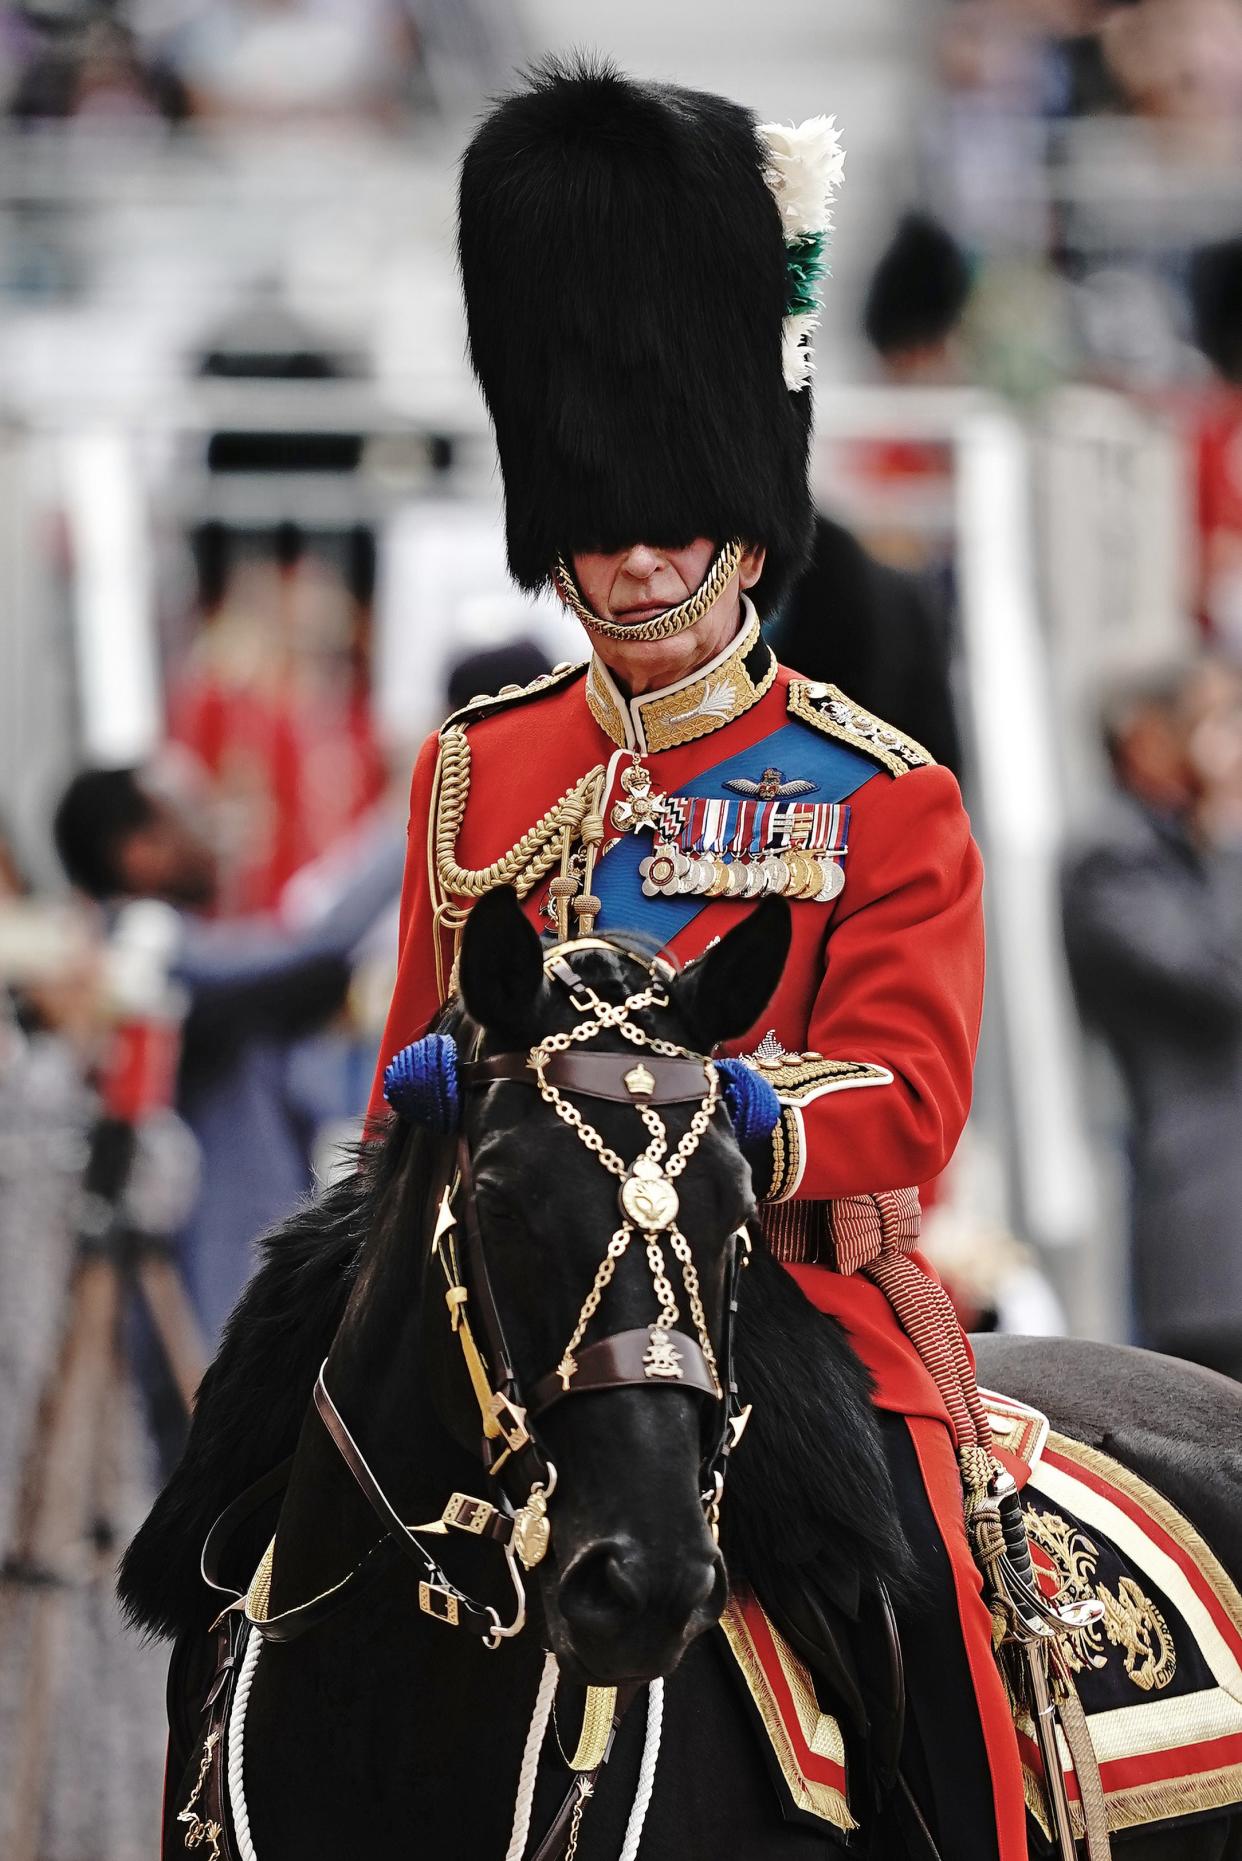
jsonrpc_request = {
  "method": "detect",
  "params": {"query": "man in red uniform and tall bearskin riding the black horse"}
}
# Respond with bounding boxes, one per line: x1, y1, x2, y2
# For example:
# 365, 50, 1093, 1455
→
372, 63, 1028, 1861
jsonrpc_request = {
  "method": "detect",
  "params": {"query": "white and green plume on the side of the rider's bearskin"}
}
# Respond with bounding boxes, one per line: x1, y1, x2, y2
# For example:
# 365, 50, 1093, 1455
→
760, 117, 845, 391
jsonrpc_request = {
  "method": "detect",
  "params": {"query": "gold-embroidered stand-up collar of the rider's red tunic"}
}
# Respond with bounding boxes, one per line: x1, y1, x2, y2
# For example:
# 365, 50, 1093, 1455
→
587, 596, 776, 754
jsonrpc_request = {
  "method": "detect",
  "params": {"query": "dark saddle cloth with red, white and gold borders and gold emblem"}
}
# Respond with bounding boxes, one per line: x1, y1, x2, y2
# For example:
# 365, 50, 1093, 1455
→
721, 1390, 1242, 1837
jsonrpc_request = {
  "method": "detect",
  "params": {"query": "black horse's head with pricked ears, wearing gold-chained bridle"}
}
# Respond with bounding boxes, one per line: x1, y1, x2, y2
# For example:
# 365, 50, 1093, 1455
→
446, 891, 790, 1682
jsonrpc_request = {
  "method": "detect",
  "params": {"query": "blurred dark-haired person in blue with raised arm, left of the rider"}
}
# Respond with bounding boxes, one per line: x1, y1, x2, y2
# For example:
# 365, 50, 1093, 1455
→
54, 765, 404, 1340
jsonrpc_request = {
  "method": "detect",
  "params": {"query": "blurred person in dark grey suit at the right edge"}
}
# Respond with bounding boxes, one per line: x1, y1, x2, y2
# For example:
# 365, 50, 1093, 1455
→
1063, 661, 1242, 1379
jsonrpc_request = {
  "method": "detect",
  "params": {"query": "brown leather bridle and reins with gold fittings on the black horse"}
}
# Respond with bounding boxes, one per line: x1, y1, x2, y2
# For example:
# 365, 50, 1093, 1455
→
215, 938, 750, 1667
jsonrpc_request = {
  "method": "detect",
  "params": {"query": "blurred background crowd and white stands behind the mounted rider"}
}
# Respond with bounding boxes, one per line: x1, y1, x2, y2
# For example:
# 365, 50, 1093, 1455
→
0, 0, 1242, 1861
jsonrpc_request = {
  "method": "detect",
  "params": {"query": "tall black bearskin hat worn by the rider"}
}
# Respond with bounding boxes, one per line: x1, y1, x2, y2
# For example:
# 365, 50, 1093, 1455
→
458, 58, 812, 609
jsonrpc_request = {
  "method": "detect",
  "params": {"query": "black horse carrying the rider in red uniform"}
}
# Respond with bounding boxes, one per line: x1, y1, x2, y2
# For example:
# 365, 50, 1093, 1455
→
121, 893, 1242, 1861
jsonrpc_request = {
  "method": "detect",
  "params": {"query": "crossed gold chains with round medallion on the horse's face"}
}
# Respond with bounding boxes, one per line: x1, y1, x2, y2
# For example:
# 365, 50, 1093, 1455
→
531, 983, 722, 1396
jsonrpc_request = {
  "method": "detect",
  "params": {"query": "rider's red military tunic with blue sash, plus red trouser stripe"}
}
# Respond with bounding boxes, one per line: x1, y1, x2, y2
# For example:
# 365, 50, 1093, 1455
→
372, 603, 1026, 1861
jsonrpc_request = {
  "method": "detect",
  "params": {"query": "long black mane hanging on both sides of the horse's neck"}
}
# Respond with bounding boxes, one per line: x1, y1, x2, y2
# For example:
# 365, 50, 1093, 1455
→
119, 982, 907, 1636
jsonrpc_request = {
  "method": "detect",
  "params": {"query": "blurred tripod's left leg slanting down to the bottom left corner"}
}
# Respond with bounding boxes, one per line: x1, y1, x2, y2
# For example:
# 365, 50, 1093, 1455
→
0, 1258, 119, 1861
